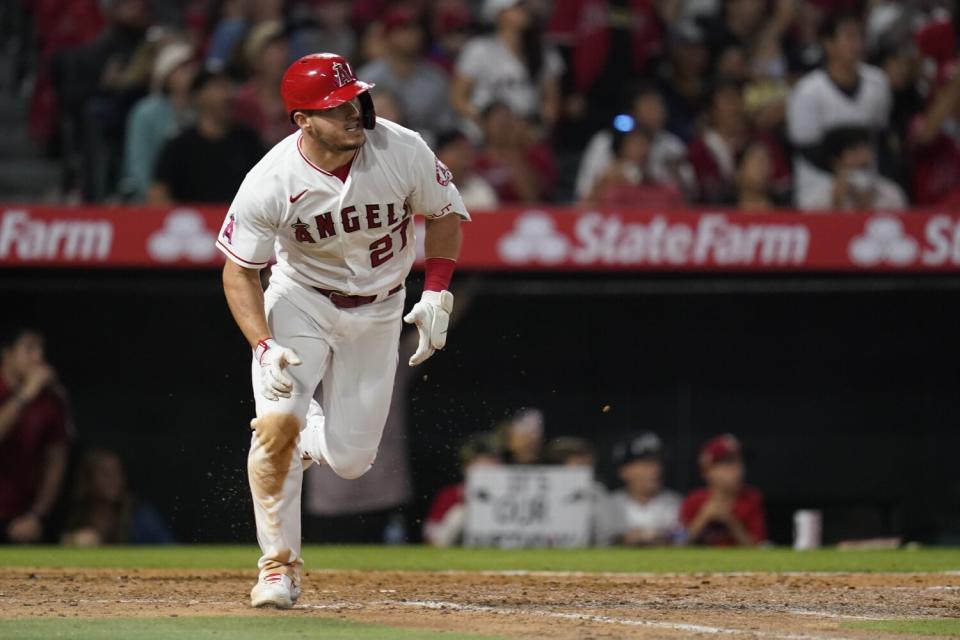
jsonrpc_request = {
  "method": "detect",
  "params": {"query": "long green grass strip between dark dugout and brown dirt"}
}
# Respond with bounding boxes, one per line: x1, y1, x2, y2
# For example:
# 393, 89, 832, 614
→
0, 545, 960, 573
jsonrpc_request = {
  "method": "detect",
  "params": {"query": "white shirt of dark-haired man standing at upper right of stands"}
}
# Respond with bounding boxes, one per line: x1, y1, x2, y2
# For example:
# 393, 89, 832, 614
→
787, 64, 893, 196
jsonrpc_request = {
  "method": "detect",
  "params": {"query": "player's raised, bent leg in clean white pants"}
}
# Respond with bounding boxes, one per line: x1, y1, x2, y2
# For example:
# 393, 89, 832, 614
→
316, 294, 404, 479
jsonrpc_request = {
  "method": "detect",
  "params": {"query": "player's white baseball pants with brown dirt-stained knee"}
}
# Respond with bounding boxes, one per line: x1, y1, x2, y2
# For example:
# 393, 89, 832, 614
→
247, 282, 404, 583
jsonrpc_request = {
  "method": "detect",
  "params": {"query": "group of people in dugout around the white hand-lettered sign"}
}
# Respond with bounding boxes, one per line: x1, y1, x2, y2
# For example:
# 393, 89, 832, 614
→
423, 409, 767, 547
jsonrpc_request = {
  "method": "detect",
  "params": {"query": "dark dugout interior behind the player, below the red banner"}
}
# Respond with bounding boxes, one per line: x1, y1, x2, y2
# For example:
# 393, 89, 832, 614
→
0, 271, 960, 543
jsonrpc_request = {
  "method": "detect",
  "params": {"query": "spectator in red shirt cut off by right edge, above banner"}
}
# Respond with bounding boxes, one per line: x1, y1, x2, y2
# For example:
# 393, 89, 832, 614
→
908, 60, 960, 206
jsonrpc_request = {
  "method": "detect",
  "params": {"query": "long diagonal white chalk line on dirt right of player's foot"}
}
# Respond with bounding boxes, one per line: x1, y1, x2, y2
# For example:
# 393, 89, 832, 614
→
395, 600, 837, 640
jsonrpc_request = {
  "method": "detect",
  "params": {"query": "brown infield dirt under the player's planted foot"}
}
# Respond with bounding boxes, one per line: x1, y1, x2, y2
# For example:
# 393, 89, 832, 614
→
0, 569, 960, 640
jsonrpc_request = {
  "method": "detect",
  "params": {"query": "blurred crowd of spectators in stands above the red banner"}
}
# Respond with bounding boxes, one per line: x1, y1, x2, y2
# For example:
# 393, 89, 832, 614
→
13, 0, 960, 211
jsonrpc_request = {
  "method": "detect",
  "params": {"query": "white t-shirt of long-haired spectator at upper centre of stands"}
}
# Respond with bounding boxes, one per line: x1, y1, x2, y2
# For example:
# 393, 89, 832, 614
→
457, 36, 563, 118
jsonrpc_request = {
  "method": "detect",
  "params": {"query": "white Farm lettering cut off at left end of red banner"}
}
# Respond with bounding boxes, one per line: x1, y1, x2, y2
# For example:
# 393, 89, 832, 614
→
0, 209, 113, 262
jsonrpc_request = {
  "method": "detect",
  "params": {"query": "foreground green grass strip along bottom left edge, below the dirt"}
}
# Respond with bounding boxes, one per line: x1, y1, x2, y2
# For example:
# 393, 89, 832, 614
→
0, 616, 495, 640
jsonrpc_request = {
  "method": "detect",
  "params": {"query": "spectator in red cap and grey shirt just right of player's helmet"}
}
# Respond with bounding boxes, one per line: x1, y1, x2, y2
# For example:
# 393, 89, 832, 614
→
357, 7, 455, 144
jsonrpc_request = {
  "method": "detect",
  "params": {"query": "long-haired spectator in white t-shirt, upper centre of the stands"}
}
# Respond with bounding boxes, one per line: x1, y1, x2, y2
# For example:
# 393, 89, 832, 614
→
451, 0, 563, 128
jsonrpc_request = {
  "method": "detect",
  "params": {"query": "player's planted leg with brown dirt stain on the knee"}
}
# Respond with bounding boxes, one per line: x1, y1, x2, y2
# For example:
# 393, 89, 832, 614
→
247, 296, 330, 606
